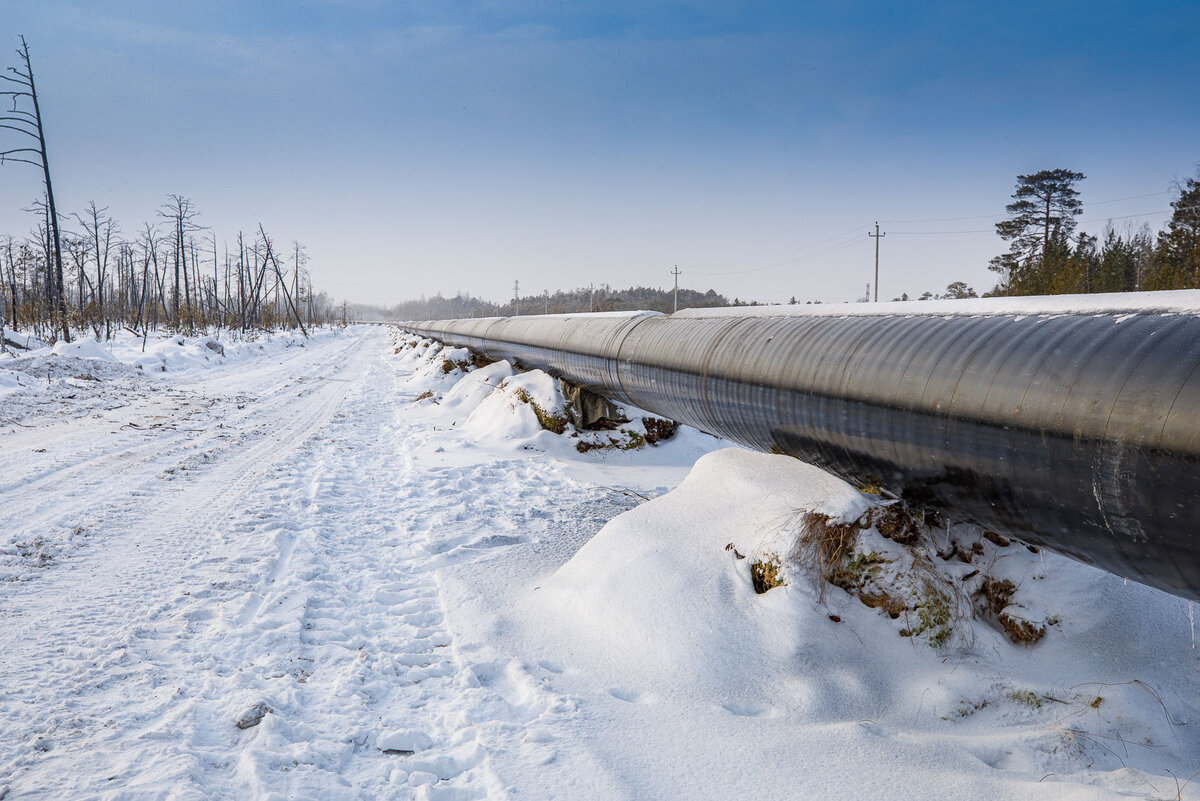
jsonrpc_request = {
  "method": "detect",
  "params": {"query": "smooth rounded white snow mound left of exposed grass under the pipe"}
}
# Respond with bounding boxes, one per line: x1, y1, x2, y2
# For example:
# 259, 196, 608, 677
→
542, 448, 869, 689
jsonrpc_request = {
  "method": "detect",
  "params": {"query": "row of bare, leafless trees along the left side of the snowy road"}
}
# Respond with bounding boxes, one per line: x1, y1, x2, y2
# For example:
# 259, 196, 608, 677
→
0, 194, 340, 342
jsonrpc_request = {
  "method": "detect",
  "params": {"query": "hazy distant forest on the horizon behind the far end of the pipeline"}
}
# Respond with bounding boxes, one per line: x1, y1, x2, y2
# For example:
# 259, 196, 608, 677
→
352, 284, 794, 320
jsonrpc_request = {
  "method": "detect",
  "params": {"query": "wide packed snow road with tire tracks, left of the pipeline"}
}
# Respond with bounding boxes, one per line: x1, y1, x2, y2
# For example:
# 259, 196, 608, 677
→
0, 331, 578, 799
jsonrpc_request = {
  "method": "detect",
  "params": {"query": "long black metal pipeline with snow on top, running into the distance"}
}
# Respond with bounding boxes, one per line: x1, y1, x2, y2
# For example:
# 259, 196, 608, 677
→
404, 291, 1200, 600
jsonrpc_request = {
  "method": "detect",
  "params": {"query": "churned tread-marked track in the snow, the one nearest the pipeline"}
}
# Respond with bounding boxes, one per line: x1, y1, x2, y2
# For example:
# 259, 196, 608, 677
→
153, 352, 511, 799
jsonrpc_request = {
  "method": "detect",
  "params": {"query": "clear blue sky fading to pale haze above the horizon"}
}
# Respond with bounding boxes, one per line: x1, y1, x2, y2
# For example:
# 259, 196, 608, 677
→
0, 0, 1200, 302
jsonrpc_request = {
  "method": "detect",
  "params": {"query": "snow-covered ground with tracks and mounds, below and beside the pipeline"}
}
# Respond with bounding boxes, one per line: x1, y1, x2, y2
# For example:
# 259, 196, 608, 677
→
0, 327, 1200, 801
